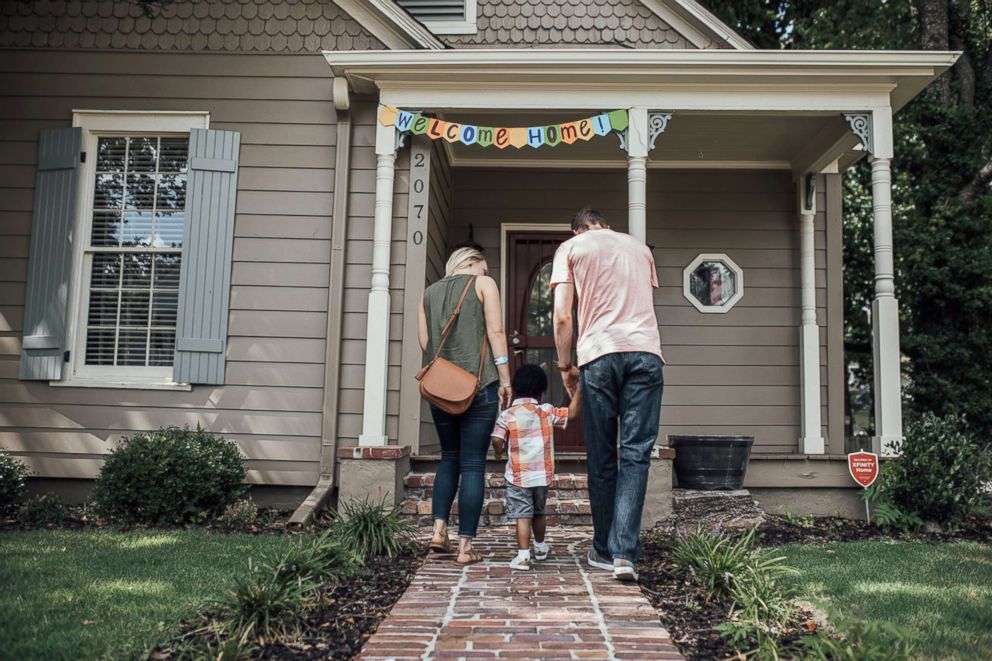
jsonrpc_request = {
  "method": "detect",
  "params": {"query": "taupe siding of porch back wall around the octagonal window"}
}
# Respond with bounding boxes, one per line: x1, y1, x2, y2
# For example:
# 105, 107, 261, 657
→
448, 169, 828, 452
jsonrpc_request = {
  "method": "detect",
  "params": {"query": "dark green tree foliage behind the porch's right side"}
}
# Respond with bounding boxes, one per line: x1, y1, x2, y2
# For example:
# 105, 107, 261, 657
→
705, 0, 992, 441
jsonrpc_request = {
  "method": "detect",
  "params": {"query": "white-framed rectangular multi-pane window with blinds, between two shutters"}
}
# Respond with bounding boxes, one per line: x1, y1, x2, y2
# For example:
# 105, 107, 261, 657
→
66, 113, 207, 387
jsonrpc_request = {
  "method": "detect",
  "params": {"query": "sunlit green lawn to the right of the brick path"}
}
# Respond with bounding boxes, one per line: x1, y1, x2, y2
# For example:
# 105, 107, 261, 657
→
775, 541, 992, 659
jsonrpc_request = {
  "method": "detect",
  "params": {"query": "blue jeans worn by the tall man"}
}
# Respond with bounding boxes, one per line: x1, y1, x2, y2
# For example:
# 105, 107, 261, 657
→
581, 351, 665, 562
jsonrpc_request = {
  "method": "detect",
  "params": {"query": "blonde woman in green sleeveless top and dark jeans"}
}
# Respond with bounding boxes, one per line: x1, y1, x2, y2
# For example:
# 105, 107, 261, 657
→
418, 248, 512, 565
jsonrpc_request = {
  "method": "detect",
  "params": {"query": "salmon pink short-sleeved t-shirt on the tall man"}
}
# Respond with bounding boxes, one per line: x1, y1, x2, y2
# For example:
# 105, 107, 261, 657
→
551, 229, 662, 367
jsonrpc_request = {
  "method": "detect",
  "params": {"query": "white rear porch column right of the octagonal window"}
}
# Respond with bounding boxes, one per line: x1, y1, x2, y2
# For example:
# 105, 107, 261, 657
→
798, 177, 826, 454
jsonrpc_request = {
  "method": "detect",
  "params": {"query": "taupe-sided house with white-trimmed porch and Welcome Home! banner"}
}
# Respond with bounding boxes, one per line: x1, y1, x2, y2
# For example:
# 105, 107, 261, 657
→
0, 0, 956, 517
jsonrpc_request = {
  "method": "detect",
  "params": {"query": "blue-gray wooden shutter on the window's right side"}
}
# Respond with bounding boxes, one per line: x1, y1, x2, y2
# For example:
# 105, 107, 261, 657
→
172, 129, 241, 384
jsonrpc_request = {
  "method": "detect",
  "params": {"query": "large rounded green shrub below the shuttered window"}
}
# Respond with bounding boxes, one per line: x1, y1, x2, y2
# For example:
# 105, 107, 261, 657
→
93, 426, 245, 524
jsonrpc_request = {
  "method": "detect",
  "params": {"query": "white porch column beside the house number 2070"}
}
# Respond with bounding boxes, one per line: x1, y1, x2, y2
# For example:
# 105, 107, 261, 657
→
360, 119, 396, 446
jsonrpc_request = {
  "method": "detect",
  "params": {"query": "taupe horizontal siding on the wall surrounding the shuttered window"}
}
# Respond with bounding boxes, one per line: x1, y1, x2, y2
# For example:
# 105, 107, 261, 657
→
0, 51, 338, 484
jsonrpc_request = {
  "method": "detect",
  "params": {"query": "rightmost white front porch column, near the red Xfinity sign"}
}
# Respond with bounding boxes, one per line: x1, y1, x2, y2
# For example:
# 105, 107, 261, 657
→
871, 108, 902, 456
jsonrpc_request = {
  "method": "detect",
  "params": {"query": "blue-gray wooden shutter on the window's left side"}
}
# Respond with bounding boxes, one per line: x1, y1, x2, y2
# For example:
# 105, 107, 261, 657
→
20, 128, 83, 381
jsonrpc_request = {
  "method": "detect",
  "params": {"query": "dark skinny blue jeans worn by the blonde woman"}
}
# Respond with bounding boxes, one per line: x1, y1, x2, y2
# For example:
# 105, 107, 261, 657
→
431, 381, 499, 537
